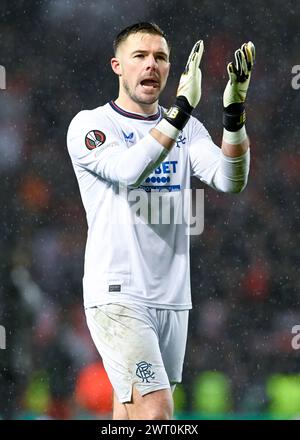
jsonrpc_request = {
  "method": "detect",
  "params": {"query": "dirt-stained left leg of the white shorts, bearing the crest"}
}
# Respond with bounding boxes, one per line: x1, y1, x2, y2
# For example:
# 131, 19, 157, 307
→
86, 304, 170, 403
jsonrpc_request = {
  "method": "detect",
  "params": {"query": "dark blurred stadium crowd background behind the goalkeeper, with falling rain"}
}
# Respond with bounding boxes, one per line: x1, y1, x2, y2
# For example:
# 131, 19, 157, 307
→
0, 0, 300, 419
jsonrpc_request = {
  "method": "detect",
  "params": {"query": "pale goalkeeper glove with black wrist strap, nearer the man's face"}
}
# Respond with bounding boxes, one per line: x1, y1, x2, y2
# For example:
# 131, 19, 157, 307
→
164, 40, 203, 130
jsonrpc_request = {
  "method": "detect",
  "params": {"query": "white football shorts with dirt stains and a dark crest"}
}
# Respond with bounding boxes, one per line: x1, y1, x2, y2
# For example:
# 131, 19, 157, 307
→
85, 303, 189, 403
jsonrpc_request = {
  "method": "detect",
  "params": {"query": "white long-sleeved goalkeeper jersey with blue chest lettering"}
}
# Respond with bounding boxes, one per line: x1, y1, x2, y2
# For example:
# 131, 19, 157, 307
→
67, 101, 248, 310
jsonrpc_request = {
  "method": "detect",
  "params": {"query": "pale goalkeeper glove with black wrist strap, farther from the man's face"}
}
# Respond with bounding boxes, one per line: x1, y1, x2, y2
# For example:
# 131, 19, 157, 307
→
223, 41, 255, 131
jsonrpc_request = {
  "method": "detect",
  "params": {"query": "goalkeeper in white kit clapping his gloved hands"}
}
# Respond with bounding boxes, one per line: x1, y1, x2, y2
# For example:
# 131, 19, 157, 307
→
67, 23, 255, 420
